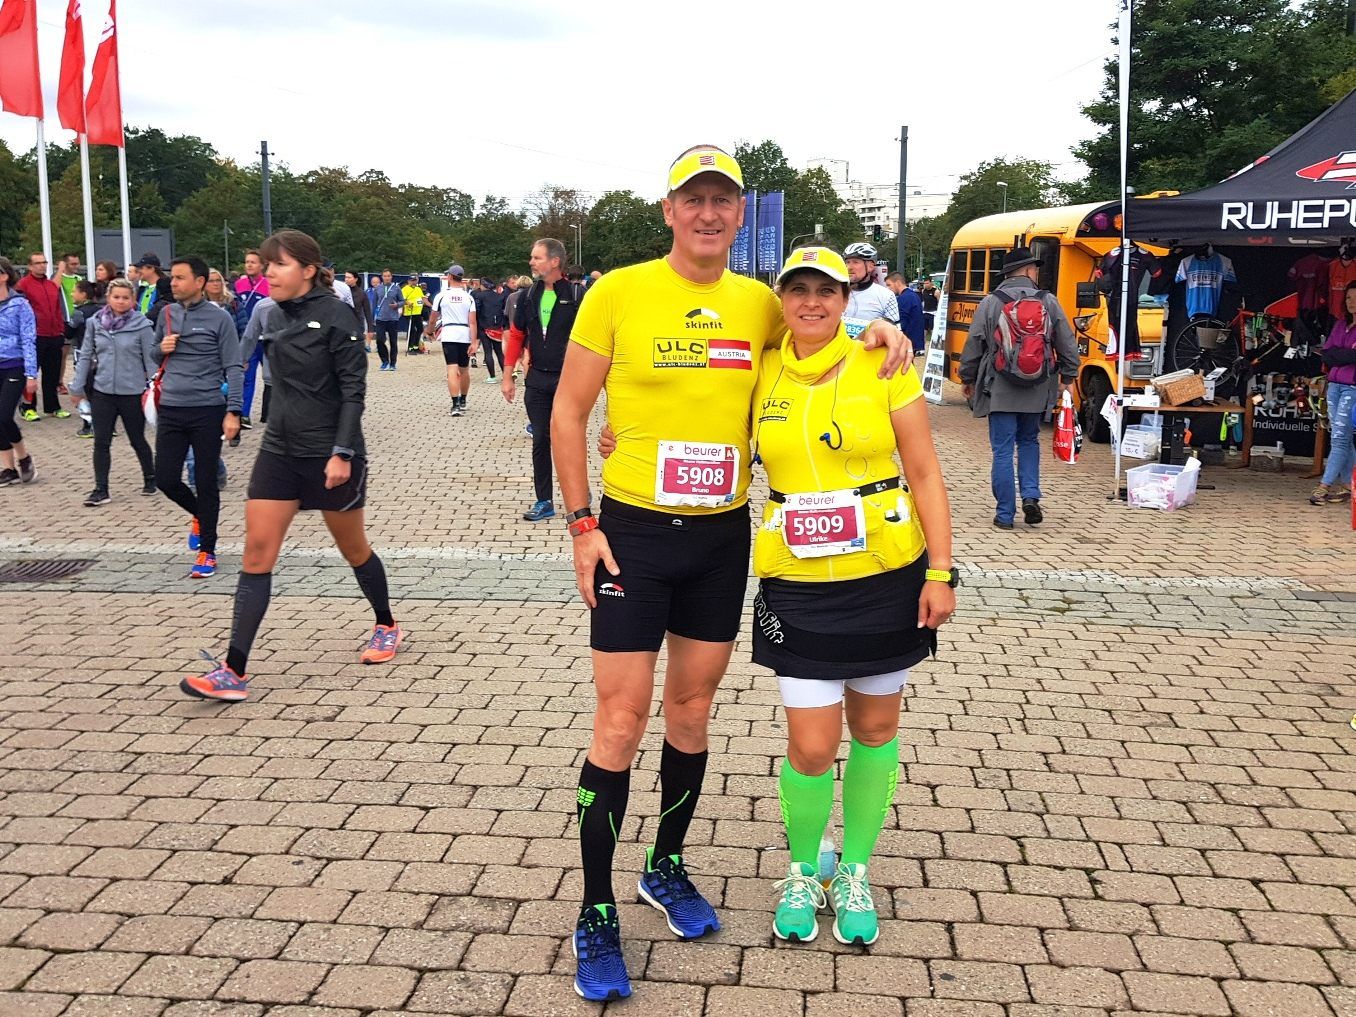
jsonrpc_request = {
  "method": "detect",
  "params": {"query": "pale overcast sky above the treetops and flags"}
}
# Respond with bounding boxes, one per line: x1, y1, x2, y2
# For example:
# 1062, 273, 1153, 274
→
0, 0, 1117, 203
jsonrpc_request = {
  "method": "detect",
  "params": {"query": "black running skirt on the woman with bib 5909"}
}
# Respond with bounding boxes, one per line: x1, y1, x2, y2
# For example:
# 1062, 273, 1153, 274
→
754, 553, 937, 681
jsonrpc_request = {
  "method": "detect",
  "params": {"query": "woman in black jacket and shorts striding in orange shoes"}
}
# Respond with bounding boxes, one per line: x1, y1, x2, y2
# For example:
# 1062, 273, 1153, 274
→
179, 229, 404, 702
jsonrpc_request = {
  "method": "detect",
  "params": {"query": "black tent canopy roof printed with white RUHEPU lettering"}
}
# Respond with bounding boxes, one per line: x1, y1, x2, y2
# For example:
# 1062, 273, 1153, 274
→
1125, 91, 1356, 247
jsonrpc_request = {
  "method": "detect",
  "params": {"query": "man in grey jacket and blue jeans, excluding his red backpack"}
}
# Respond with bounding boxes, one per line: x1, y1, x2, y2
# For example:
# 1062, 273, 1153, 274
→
960, 247, 1078, 530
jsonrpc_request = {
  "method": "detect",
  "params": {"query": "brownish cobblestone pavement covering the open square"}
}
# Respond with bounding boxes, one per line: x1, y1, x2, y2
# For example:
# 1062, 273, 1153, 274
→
0, 347, 1356, 1017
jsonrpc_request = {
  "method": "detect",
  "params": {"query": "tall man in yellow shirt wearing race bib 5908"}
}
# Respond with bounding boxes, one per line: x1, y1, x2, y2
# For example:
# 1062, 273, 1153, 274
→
552, 145, 909, 999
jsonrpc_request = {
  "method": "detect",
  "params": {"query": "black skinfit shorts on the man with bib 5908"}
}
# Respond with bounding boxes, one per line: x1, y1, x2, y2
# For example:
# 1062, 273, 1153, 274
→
589, 498, 750, 654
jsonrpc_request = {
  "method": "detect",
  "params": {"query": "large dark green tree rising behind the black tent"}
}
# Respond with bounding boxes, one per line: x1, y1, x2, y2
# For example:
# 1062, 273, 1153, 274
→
1074, 0, 1356, 201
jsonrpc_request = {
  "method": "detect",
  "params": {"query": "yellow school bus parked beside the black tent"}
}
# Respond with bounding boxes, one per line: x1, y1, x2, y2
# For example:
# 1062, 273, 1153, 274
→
946, 202, 1165, 442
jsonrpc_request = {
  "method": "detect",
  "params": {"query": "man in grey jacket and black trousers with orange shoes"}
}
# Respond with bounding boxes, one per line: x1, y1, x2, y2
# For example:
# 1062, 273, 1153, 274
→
156, 256, 244, 579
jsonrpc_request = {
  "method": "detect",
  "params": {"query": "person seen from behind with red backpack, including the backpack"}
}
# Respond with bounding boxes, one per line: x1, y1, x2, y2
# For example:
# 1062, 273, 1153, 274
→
960, 247, 1078, 530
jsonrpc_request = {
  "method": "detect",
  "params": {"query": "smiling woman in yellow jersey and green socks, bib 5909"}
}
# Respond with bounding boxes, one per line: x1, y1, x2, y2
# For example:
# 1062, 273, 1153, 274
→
753, 247, 956, 944
